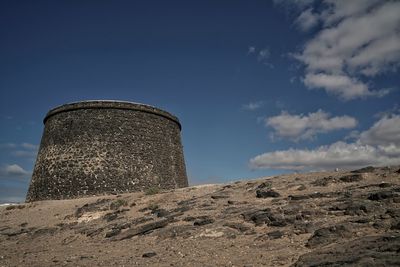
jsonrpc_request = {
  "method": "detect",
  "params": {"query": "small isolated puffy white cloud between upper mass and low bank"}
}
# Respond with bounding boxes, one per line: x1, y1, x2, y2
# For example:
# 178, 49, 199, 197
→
265, 110, 357, 141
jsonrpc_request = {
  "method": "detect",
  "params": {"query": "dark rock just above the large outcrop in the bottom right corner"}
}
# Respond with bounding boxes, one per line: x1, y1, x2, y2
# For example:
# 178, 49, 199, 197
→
306, 224, 352, 248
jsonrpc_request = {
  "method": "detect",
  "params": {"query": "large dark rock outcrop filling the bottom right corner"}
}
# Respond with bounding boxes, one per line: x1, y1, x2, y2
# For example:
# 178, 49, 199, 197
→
293, 233, 400, 267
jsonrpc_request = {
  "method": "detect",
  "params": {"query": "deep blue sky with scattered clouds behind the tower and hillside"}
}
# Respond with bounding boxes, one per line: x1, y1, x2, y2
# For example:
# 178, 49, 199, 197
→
0, 0, 400, 202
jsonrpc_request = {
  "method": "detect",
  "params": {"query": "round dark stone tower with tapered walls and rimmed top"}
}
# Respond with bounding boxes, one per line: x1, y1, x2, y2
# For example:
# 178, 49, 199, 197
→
26, 101, 188, 202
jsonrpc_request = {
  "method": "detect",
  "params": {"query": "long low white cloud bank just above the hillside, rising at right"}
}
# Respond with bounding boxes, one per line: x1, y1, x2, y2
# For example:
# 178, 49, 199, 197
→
250, 115, 400, 170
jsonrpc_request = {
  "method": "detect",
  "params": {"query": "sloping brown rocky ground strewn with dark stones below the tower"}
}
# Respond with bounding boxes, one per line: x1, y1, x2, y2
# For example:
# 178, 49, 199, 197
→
0, 166, 400, 267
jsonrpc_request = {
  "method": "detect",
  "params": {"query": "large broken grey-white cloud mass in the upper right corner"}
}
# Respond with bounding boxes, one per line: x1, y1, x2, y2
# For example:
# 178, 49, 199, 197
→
293, 0, 400, 100
